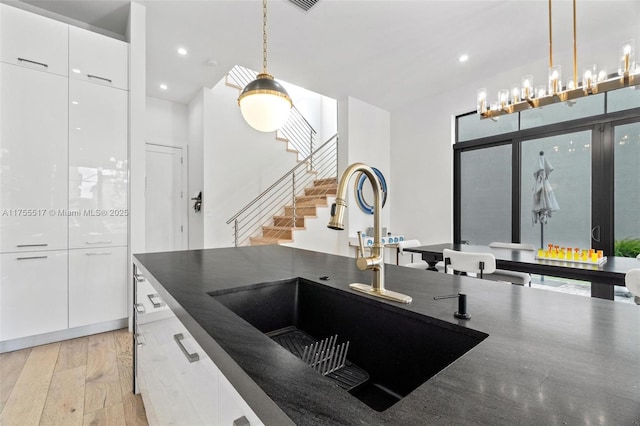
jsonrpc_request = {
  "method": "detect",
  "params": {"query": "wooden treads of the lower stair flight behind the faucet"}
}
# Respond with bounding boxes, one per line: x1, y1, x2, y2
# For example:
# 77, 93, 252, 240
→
249, 178, 338, 246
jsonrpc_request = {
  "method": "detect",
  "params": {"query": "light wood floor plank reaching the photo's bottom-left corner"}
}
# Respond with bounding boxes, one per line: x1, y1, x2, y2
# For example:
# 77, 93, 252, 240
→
0, 342, 60, 426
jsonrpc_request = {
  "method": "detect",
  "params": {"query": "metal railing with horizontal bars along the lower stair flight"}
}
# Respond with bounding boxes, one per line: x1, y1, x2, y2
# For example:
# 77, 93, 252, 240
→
227, 133, 338, 247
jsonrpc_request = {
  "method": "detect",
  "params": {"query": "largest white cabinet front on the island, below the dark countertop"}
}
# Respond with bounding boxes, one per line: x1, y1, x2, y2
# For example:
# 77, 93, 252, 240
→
138, 316, 218, 425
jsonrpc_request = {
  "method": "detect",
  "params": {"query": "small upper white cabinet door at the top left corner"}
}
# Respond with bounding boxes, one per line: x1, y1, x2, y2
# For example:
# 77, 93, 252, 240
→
0, 4, 69, 75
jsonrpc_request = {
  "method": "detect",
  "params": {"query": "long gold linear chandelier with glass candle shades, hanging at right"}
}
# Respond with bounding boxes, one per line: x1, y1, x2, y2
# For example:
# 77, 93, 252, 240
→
476, 0, 640, 118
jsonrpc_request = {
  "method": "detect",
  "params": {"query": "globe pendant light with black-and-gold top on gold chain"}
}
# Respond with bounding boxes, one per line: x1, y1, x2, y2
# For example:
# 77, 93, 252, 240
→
238, 0, 293, 132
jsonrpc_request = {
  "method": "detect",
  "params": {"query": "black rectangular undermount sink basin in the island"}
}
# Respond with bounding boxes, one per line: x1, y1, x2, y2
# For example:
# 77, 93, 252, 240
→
209, 278, 488, 411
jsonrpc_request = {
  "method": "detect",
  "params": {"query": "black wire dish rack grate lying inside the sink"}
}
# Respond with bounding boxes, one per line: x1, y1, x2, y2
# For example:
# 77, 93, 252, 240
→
267, 327, 369, 390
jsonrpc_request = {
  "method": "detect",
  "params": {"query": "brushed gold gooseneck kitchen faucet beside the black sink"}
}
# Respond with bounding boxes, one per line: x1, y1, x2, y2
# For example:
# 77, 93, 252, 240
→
327, 163, 412, 303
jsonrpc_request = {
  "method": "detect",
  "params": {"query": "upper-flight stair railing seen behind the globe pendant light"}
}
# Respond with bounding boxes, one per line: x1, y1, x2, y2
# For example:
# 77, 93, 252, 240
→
226, 65, 317, 161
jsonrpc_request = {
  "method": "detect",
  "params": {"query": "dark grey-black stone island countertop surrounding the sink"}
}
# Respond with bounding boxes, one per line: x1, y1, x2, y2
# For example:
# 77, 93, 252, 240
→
134, 246, 640, 426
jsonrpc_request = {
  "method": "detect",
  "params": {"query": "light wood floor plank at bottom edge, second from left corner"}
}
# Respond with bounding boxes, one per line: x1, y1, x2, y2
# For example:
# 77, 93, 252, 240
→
40, 365, 86, 426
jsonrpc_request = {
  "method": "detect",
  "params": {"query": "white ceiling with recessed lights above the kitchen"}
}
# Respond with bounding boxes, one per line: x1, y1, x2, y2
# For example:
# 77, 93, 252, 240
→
13, 0, 640, 111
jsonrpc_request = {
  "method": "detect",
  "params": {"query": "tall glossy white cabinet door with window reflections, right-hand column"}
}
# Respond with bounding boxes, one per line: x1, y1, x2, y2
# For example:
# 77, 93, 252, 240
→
69, 80, 128, 249
